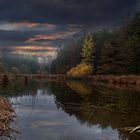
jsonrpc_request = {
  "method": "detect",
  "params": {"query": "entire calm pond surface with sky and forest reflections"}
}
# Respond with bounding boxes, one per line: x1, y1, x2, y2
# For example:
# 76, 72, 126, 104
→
1, 81, 140, 140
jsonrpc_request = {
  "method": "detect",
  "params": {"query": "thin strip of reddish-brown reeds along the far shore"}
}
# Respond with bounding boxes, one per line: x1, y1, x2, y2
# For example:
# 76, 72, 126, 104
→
0, 74, 140, 86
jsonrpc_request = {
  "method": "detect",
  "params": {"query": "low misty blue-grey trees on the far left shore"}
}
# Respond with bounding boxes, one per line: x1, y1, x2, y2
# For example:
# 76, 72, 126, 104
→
0, 52, 40, 74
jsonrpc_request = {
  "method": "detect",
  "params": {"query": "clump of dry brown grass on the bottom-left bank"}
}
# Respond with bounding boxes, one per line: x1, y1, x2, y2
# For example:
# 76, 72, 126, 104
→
0, 96, 17, 138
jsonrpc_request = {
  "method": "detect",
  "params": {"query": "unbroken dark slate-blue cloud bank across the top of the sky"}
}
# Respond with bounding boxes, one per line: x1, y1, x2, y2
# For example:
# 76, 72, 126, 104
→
0, 0, 137, 24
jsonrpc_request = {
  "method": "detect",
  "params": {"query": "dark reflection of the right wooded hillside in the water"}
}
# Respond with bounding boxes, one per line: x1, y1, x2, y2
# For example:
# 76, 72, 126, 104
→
51, 81, 140, 140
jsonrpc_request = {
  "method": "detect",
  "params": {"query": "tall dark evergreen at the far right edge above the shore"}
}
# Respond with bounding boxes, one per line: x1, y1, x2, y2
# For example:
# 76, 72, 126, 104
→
124, 12, 140, 74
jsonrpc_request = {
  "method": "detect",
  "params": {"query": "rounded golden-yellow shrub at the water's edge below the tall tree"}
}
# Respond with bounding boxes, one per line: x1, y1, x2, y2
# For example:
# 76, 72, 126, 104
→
67, 63, 93, 78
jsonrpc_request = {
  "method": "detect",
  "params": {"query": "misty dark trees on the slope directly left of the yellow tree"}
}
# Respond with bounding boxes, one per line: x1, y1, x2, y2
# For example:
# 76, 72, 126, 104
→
50, 39, 83, 74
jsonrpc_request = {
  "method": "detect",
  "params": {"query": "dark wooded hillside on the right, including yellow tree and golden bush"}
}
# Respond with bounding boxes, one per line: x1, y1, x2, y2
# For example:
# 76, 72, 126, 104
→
50, 12, 140, 75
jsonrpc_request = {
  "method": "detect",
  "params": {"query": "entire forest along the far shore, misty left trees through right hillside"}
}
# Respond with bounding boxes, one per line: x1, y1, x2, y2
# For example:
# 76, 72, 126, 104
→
0, 12, 140, 77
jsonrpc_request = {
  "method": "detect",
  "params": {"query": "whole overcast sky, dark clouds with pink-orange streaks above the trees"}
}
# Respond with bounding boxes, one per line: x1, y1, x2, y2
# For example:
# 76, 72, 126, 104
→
0, 0, 139, 56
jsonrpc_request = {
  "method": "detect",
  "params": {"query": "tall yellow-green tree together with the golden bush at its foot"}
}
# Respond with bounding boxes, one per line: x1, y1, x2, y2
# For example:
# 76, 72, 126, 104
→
67, 35, 95, 78
